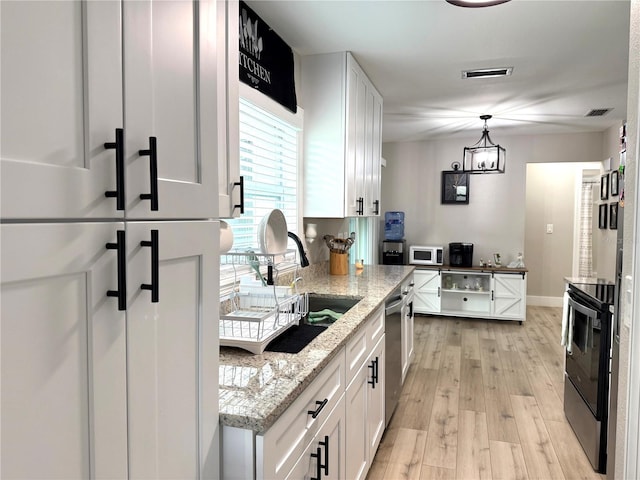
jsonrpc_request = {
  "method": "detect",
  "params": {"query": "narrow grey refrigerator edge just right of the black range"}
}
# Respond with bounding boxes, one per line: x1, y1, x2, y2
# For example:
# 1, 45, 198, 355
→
607, 203, 624, 480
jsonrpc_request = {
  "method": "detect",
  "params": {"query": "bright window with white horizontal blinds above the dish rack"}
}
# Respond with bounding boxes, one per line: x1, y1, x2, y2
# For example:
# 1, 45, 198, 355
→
220, 85, 302, 290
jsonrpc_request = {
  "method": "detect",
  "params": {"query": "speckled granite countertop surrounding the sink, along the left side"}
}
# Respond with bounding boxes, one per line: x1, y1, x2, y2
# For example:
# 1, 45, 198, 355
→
219, 265, 414, 434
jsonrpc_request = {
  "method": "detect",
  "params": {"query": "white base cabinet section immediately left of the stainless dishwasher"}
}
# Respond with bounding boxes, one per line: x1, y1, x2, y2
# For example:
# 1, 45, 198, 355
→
345, 311, 385, 480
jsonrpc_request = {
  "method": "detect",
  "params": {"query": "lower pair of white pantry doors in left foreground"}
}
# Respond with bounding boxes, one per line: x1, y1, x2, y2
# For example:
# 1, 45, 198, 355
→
1, 221, 219, 479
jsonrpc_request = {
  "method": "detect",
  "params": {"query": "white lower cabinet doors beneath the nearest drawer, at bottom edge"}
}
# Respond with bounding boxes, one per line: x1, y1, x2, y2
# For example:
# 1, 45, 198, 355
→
287, 397, 344, 480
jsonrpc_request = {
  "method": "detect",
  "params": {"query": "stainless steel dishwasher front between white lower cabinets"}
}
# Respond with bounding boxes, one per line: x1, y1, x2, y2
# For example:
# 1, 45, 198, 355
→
384, 288, 403, 425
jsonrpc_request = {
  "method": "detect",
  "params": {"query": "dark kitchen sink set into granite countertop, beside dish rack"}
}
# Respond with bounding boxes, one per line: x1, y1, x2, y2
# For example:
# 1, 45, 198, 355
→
265, 293, 362, 353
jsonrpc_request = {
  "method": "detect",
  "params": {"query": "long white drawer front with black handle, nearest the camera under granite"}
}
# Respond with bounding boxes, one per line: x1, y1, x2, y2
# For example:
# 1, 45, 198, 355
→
256, 351, 345, 479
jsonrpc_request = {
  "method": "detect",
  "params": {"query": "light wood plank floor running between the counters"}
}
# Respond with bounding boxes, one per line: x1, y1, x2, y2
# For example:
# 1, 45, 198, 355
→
368, 307, 605, 480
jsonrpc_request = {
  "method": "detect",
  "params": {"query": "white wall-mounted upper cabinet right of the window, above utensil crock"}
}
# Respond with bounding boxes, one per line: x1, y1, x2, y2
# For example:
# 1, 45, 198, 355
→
301, 52, 382, 218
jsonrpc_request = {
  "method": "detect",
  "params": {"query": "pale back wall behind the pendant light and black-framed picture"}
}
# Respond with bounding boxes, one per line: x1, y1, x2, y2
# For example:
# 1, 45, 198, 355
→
381, 131, 604, 295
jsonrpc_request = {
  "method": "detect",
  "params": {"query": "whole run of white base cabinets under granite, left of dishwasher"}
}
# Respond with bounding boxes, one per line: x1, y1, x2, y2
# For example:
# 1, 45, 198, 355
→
222, 308, 385, 480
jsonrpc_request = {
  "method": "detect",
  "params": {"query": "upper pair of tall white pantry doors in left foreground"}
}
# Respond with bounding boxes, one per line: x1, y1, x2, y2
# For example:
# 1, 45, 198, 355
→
1, 1, 224, 219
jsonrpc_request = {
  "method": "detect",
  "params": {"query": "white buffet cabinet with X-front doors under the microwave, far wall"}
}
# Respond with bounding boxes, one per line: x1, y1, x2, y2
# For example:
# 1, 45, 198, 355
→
414, 266, 527, 322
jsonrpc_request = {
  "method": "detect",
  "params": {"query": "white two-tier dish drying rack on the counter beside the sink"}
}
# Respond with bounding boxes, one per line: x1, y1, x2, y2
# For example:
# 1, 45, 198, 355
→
219, 250, 309, 354
